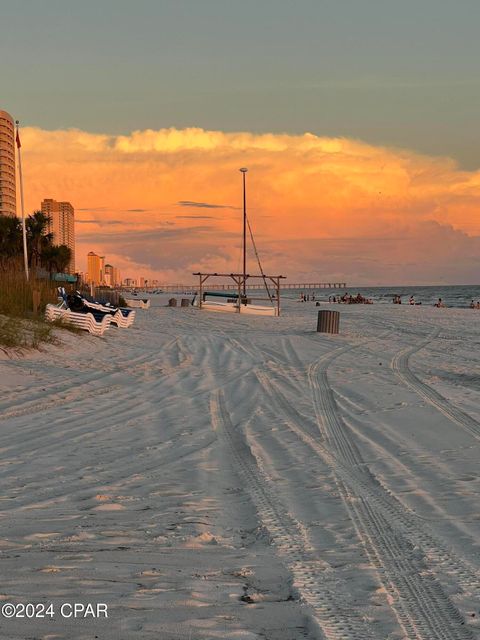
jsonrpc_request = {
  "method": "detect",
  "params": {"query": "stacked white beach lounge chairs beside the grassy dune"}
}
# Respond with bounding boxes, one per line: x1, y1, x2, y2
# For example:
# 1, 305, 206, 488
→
45, 287, 135, 336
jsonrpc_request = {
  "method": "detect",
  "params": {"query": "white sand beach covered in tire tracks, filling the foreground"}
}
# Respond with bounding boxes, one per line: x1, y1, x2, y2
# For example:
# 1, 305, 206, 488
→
0, 296, 480, 640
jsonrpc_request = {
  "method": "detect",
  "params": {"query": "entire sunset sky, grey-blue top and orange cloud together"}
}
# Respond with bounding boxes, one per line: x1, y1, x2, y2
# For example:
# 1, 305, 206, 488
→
0, 0, 480, 285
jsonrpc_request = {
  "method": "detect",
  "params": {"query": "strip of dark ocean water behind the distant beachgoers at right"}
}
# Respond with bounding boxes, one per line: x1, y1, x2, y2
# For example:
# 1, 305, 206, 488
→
282, 285, 480, 308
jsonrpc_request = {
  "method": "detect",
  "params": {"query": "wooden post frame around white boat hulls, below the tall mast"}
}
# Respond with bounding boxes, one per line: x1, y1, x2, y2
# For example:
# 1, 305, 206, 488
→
193, 272, 285, 316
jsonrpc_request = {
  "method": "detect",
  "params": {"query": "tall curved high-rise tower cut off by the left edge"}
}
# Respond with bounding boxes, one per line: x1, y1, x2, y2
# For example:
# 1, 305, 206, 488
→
0, 111, 17, 216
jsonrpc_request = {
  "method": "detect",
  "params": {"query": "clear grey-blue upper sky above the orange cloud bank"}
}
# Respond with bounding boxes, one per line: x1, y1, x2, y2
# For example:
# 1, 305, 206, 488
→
0, 0, 480, 168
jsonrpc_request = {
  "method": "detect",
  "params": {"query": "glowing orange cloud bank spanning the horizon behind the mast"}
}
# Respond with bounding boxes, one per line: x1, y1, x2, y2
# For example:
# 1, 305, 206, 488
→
22, 128, 480, 283
